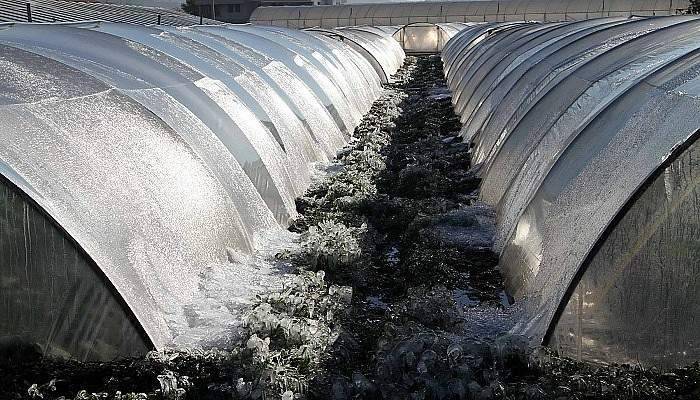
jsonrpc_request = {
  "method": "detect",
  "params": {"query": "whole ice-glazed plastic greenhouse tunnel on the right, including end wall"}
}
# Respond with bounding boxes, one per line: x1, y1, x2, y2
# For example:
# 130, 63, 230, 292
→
442, 16, 700, 367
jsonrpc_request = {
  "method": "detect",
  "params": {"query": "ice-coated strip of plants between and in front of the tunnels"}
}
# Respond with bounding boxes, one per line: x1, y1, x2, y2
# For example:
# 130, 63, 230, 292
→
0, 57, 700, 400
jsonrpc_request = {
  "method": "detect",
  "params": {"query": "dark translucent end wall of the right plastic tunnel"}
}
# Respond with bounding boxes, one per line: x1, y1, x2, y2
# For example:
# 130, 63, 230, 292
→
552, 136, 700, 367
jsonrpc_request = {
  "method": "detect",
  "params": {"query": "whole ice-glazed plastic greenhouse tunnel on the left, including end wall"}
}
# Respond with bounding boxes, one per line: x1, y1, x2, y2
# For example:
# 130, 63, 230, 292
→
0, 22, 404, 360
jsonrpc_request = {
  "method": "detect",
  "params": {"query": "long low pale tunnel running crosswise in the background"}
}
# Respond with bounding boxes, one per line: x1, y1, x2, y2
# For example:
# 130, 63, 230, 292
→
251, 0, 696, 28
